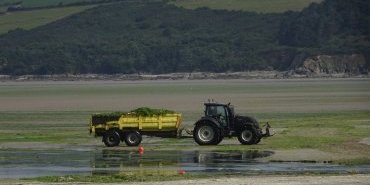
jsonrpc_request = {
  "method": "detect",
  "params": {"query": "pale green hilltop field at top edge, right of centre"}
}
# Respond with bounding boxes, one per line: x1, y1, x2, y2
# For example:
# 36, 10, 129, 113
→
174, 0, 322, 13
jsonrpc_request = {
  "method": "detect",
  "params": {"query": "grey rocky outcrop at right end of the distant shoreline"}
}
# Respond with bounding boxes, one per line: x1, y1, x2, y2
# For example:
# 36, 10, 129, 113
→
296, 54, 367, 75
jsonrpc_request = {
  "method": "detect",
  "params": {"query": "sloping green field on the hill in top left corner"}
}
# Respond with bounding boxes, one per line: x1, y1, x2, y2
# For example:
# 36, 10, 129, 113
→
0, 6, 93, 34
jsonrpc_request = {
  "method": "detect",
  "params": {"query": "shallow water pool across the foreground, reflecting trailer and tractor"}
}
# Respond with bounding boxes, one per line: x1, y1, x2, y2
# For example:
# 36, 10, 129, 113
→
0, 149, 370, 179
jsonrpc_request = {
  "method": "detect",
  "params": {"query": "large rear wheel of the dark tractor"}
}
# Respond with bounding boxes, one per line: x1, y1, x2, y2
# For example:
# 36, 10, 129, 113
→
193, 123, 222, 145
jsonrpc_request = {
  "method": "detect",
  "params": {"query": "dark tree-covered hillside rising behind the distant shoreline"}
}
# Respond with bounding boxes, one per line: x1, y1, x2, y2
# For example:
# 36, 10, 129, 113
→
0, 0, 370, 75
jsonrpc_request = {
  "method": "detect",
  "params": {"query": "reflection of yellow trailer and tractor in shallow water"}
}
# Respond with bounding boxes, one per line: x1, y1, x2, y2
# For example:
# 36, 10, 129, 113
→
92, 149, 272, 174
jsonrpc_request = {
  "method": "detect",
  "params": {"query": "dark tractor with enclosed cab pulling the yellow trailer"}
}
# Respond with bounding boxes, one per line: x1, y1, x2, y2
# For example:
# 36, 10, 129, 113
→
193, 103, 272, 145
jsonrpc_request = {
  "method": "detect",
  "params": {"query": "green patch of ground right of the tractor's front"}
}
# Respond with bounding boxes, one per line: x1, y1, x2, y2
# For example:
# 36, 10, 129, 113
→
218, 111, 370, 150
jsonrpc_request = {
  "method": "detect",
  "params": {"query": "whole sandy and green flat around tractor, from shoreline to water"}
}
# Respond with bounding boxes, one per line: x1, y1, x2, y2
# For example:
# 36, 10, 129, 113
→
0, 79, 370, 182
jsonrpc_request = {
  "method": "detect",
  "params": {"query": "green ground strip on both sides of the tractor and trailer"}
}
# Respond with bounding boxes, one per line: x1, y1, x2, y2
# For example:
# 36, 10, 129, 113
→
0, 111, 370, 150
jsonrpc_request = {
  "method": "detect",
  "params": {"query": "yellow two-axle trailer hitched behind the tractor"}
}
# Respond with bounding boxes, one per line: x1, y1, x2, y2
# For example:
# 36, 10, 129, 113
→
89, 112, 182, 147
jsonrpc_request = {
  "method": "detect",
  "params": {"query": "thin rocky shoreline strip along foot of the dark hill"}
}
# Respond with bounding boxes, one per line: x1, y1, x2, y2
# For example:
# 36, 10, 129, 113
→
0, 71, 370, 81
